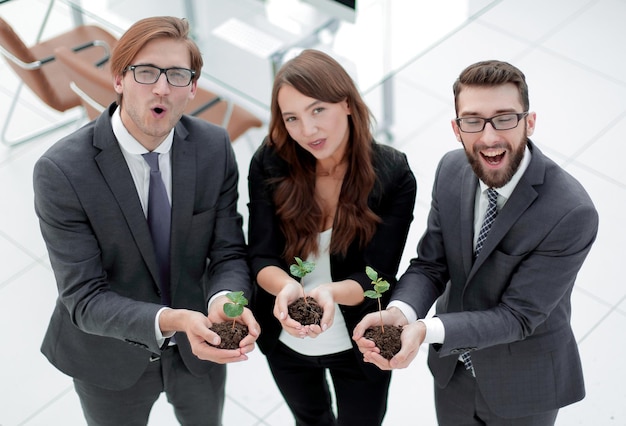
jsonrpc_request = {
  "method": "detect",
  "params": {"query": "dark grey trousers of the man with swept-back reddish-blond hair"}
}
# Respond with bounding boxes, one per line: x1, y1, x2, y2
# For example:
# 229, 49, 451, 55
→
74, 346, 226, 426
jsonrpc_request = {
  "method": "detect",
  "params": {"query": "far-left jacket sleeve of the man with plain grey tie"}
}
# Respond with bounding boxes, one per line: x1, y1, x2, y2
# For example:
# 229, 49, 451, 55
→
33, 157, 160, 352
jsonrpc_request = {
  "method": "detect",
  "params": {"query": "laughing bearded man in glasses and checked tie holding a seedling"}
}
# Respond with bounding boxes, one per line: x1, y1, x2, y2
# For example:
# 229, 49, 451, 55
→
353, 61, 598, 426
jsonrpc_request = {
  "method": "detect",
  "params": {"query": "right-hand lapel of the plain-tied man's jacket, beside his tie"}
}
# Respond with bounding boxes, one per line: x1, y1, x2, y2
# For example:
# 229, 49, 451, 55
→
170, 123, 197, 300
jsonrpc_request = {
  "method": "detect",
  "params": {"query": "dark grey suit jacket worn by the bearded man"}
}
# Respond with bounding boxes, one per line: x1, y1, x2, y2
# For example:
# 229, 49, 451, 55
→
392, 143, 598, 417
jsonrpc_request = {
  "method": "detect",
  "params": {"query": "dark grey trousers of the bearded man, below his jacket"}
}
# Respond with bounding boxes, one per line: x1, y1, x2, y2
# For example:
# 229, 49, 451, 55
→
435, 362, 559, 426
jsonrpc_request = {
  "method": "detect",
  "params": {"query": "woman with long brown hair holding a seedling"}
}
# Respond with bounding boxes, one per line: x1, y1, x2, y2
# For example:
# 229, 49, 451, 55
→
248, 50, 416, 425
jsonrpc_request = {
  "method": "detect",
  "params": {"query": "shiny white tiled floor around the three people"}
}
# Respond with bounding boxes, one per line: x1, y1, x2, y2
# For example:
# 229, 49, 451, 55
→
0, 0, 626, 426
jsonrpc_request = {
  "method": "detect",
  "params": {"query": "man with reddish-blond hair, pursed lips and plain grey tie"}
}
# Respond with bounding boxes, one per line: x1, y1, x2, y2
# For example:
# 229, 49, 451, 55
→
34, 17, 260, 426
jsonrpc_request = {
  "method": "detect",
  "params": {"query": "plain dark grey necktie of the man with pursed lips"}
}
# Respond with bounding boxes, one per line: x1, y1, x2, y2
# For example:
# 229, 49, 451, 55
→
143, 152, 172, 306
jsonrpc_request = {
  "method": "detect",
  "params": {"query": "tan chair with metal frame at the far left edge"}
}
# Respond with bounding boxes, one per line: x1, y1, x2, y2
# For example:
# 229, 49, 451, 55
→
0, 18, 117, 146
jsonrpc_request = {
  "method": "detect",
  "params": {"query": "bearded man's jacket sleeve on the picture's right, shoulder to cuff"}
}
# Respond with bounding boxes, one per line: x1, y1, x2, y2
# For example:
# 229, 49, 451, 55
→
439, 203, 598, 356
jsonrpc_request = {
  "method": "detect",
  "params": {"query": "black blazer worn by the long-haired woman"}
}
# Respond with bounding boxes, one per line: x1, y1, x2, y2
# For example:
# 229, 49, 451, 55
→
248, 143, 417, 370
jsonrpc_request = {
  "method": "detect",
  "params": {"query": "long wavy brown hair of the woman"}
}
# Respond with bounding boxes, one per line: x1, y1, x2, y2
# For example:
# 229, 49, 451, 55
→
268, 49, 380, 262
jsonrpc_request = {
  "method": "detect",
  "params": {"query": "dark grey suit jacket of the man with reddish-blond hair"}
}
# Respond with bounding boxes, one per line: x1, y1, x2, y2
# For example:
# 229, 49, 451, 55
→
34, 105, 251, 390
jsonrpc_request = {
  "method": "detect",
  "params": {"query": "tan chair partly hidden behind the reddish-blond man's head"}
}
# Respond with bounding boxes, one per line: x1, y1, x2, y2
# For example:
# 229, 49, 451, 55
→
54, 47, 263, 141
